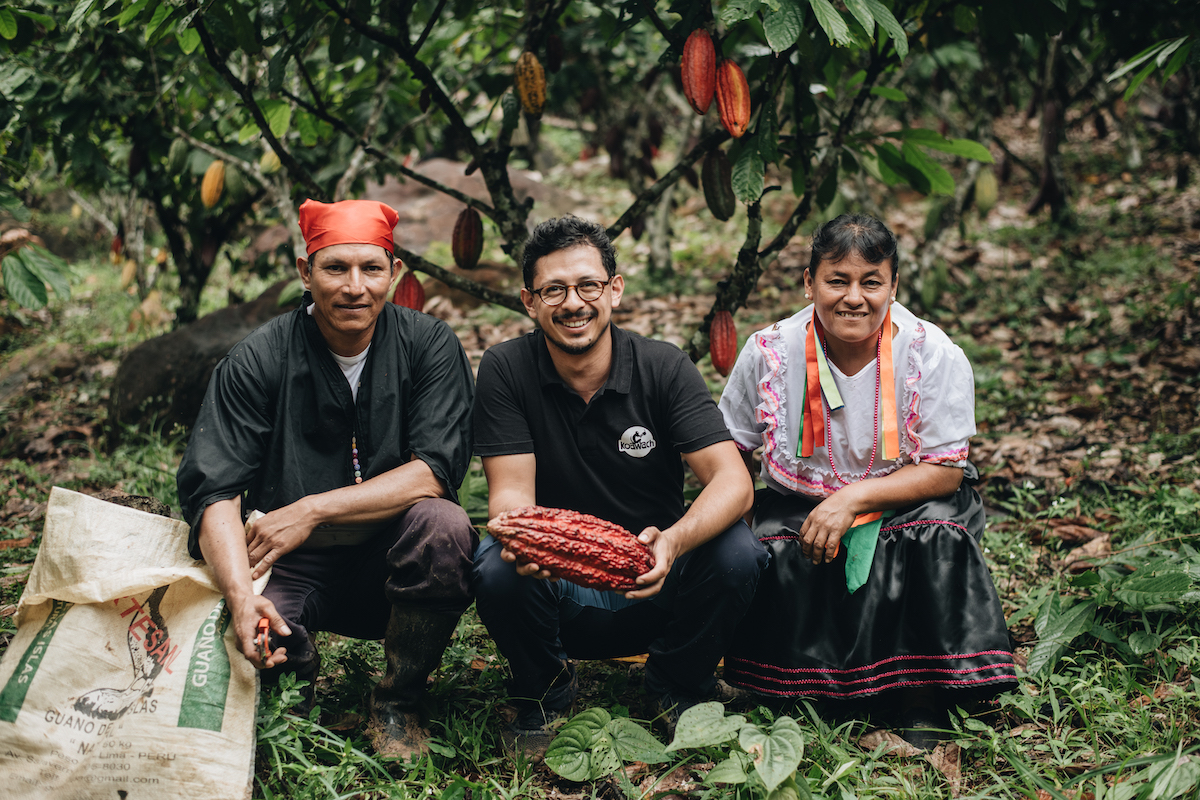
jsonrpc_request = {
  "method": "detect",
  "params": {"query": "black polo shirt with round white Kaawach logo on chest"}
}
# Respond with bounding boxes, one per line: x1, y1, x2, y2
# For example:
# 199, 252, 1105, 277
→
474, 325, 732, 534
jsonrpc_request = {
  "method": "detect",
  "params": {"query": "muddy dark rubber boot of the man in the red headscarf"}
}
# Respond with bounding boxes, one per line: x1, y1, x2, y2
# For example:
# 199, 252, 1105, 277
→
367, 606, 461, 762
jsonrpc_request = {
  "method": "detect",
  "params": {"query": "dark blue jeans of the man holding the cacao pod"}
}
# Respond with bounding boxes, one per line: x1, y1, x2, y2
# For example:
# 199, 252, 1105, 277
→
473, 521, 768, 710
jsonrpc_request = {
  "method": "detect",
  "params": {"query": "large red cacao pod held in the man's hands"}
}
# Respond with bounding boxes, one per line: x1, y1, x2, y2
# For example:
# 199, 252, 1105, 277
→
487, 506, 654, 591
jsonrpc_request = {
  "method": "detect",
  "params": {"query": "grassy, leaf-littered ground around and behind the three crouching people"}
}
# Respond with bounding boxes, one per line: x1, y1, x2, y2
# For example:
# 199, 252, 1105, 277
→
0, 113, 1200, 800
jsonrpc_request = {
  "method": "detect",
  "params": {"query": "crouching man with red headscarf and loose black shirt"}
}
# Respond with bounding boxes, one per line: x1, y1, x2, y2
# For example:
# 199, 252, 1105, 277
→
178, 200, 475, 759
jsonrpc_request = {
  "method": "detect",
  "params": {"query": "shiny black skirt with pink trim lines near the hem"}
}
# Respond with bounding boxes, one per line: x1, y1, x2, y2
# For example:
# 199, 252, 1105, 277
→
725, 469, 1016, 702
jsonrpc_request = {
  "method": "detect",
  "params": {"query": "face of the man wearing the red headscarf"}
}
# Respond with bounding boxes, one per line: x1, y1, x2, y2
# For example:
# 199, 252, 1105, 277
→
296, 245, 394, 356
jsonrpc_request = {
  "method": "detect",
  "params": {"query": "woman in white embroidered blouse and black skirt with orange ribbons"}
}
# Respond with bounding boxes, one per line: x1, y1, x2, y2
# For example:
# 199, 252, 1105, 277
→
720, 215, 1015, 746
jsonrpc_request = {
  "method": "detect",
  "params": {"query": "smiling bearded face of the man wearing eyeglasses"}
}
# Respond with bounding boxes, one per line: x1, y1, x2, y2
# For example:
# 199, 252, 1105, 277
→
521, 245, 625, 355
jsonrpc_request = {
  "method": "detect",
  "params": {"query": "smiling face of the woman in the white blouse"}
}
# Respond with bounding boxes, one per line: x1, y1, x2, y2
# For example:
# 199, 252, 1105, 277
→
804, 253, 896, 349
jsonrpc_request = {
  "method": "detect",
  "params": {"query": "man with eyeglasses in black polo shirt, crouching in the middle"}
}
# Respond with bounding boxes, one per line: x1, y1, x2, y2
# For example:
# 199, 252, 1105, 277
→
474, 217, 767, 759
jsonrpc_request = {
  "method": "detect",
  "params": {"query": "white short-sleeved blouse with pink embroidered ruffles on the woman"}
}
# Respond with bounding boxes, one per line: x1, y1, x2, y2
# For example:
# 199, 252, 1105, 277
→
720, 302, 976, 497
